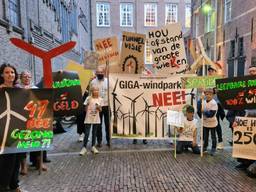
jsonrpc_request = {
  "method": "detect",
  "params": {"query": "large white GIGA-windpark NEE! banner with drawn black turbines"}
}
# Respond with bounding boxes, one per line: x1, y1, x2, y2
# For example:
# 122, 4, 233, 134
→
109, 74, 195, 139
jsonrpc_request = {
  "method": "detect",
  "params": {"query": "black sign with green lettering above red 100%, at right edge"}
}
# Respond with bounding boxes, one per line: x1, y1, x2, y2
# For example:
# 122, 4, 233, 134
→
216, 76, 256, 110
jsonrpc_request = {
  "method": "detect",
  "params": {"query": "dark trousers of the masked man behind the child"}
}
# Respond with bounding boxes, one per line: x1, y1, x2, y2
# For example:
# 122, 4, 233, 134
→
97, 106, 110, 144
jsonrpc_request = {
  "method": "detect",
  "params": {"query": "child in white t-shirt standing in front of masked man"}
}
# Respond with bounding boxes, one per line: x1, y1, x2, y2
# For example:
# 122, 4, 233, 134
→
80, 86, 103, 155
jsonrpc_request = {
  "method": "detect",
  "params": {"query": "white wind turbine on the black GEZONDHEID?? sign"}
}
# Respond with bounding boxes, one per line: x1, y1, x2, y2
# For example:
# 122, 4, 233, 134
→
0, 91, 27, 154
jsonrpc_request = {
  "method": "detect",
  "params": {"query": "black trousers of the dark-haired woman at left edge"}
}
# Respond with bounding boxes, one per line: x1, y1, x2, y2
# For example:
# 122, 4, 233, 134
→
0, 153, 20, 191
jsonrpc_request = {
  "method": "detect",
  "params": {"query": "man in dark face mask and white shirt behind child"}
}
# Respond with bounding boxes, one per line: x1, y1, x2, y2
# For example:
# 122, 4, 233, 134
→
90, 67, 110, 147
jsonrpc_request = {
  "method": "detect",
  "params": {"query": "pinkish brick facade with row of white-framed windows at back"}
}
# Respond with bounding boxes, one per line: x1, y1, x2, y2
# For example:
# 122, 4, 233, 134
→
91, 0, 191, 63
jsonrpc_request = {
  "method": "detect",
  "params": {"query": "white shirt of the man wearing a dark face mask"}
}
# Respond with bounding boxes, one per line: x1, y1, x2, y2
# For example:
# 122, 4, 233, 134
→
90, 78, 108, 106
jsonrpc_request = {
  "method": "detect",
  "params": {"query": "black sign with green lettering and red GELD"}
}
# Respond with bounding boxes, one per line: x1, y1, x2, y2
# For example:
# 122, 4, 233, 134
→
52, 71, 84, 117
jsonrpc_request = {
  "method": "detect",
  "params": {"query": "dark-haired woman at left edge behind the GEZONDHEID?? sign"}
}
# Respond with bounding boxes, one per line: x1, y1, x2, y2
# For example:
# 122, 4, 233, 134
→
0, 64, 20, 192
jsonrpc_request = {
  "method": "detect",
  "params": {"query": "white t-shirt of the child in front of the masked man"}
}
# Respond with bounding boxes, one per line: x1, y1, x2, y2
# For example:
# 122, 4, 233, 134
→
84, 96, 102, 124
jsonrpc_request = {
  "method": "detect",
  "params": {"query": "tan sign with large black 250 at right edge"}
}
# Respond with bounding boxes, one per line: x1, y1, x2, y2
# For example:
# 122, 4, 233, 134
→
232, 117, 256, 160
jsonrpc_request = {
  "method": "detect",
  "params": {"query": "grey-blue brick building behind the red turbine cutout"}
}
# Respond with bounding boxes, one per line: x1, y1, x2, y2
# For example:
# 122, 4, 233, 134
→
0, 0, 91, 82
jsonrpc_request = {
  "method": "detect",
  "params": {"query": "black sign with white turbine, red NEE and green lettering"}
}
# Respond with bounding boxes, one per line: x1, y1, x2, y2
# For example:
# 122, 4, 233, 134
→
0, 88, 53, 154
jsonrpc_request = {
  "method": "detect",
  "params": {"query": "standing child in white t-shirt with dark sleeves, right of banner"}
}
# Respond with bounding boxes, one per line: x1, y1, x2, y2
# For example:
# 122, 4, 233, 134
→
197, 89, 218, 155
